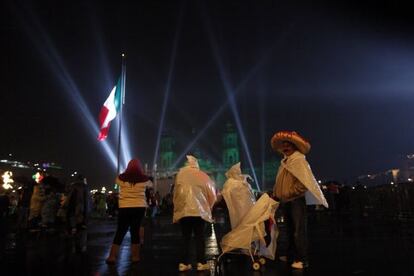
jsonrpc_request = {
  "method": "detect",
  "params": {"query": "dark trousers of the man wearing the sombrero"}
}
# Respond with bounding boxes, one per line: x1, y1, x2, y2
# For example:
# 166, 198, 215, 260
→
282, 197, 308, 262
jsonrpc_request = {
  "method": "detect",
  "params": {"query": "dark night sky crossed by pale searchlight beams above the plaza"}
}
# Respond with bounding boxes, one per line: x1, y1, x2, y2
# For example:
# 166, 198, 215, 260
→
0, 0, 414, 186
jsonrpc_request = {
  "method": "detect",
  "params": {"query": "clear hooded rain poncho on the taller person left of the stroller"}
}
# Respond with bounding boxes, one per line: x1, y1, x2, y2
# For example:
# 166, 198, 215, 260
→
173, 155, 216, 223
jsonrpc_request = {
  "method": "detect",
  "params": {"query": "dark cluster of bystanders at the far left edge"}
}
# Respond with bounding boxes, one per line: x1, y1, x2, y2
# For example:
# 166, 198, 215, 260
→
2, 173, 90, 232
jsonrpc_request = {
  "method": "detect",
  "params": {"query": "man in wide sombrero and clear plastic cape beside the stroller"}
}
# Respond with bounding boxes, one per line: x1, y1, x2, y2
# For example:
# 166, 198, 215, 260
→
271, 131, 328, 269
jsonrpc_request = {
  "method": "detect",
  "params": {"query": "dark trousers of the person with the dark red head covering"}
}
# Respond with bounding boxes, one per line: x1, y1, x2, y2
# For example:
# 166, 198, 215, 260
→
113, 207, 145, 245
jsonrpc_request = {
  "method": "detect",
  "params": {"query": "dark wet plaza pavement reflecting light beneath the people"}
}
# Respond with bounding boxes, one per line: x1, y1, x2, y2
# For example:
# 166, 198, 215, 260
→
0, 209, 414, 276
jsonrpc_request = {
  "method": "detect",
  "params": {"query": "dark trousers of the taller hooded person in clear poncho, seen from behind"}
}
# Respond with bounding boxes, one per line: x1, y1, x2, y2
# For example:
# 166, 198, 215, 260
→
180, 217, 205, 264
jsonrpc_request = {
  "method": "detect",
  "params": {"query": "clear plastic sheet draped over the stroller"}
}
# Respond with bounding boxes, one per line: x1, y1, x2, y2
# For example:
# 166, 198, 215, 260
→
220, 194, 279, 260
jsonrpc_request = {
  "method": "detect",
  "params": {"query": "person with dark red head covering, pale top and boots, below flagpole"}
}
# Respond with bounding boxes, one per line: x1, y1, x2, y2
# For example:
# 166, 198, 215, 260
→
106, 159, 152, 264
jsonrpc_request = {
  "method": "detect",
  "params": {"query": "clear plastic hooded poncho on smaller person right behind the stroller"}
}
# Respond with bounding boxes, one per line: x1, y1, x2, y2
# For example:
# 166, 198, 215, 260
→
221, 162, 256, 229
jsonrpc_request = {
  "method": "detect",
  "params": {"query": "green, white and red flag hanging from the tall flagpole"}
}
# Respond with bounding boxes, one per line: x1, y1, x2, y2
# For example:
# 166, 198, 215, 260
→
98, 78, 122, 141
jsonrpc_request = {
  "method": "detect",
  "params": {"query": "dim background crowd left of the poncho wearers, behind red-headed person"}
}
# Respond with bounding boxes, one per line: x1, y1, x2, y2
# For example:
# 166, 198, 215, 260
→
0, 174, 172, 232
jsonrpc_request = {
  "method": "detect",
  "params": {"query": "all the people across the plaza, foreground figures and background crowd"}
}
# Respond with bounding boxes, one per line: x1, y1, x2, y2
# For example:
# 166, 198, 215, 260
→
0, 131, 414, 272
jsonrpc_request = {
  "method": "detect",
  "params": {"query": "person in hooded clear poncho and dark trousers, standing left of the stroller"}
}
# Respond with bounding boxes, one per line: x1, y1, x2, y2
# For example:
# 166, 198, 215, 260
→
173, 155, 216, 271
